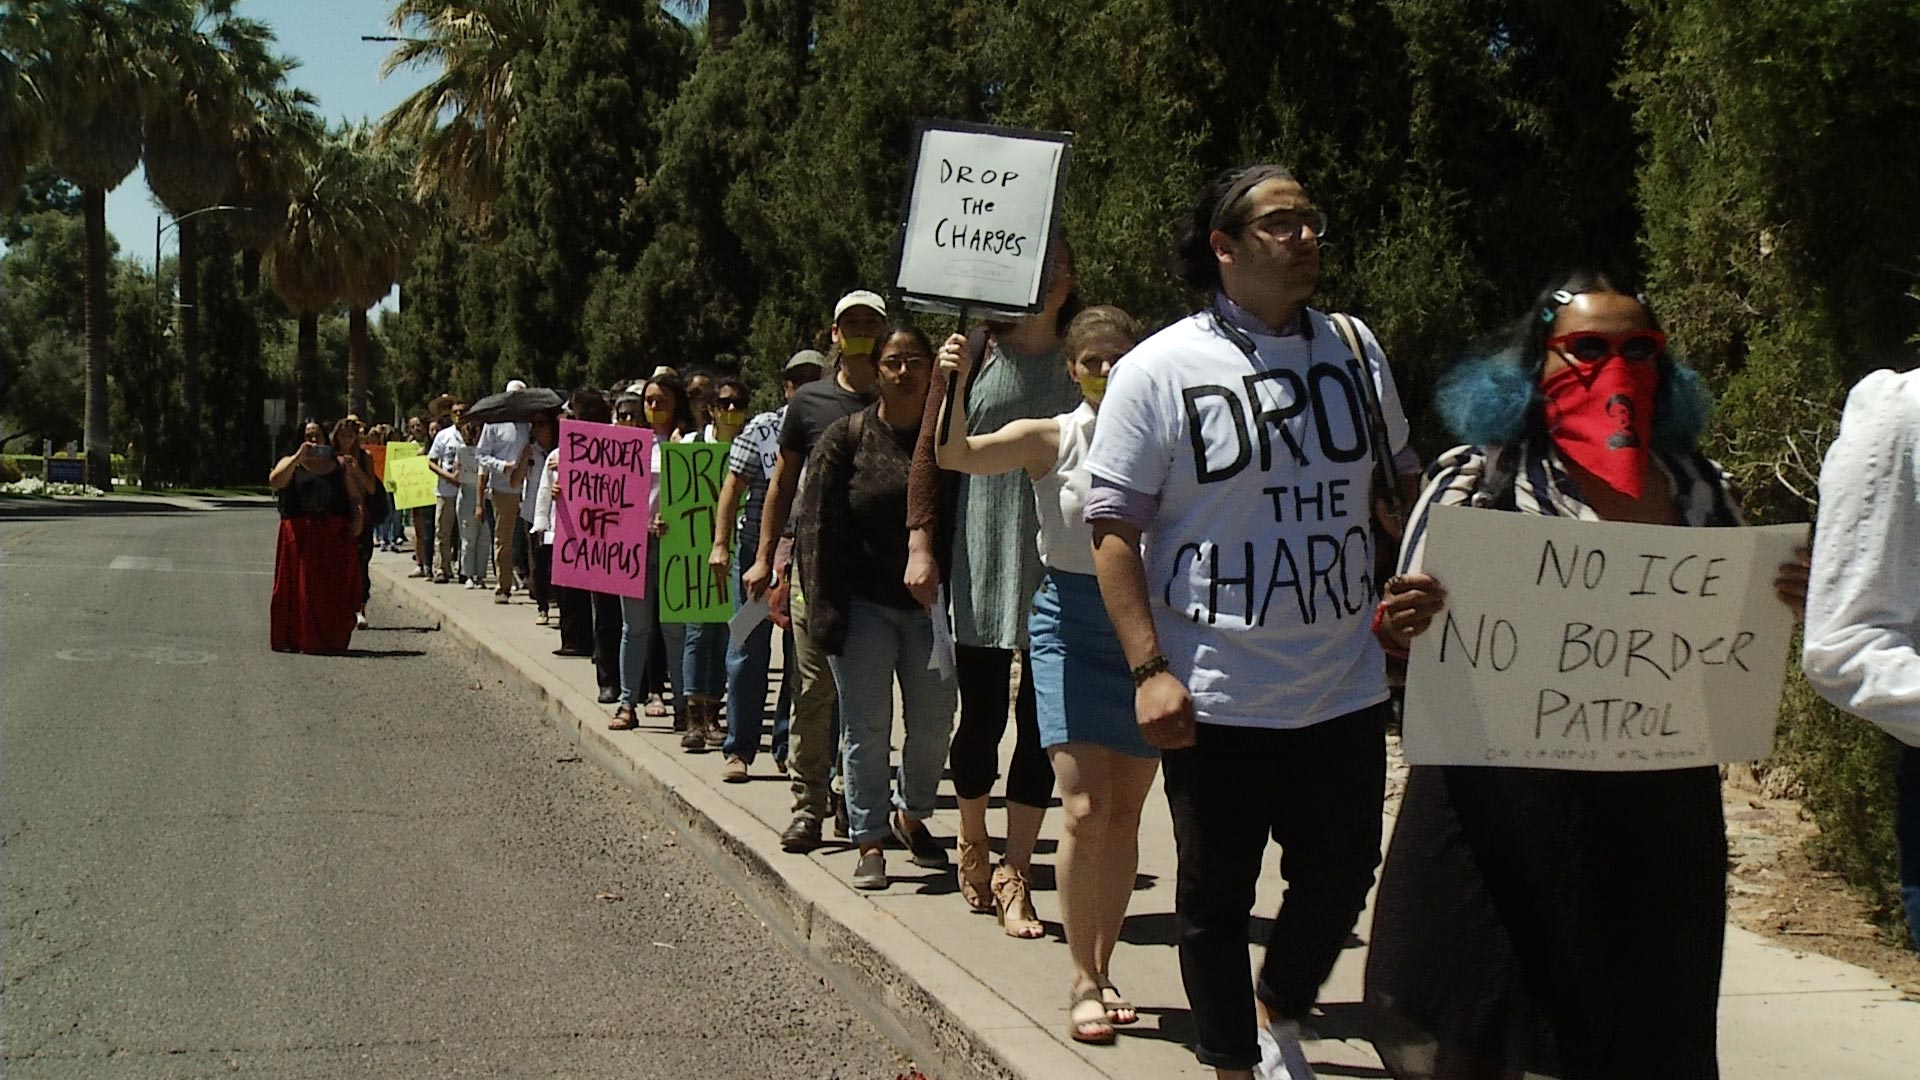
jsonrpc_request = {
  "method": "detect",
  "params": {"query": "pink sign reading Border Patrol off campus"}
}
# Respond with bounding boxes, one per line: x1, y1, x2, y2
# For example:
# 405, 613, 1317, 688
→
553, 421, 653, 596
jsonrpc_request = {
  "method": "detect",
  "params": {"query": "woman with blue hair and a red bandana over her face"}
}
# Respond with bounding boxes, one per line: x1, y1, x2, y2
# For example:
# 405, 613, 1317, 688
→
1367, 271, 1807, 1080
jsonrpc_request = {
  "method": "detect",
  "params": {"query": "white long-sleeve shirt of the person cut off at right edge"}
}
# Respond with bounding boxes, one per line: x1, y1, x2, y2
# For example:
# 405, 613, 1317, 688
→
1801, 371, 1920, 746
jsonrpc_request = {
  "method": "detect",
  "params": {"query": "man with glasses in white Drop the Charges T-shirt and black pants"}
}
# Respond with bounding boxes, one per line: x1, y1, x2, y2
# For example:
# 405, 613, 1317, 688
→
1087, 165, 1419, 1080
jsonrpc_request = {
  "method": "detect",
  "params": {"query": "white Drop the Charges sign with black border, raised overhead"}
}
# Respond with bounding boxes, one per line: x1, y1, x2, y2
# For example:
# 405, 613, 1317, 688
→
895, 121, 1071, 313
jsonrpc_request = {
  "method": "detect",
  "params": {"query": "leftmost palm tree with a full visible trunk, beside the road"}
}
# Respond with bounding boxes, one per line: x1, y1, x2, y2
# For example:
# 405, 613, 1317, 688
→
29, 0, 159, 490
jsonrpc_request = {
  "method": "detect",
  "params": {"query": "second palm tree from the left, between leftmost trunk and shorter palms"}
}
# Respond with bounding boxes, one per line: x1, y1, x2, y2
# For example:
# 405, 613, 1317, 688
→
146, 0, 280, 451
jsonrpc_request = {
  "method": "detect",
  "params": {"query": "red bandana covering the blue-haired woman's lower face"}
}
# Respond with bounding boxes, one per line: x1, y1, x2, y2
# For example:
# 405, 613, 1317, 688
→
1540, 356, 1661, 498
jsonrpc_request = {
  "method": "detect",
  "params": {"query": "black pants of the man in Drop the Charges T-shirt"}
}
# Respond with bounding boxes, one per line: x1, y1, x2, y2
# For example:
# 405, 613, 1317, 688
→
1162, 703, 1388, 1068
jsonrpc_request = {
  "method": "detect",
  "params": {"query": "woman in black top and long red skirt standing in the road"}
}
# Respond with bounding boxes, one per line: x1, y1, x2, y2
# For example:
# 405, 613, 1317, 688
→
267, 421, 365, 653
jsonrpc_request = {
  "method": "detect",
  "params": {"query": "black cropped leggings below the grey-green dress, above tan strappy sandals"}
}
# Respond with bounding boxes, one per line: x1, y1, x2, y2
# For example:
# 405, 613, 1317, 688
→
947, 646, 1054, 807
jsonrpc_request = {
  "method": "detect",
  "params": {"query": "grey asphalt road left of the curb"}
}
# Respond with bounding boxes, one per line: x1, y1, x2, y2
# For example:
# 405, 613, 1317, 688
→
0, 503, 908, 1080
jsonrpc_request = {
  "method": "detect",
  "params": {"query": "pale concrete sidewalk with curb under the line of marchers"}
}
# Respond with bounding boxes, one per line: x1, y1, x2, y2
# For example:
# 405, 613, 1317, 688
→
374, 553, 1920, 1080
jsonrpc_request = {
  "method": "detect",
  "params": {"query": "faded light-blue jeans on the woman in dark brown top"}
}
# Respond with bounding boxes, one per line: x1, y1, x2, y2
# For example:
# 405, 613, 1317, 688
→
828, 600, 958, 844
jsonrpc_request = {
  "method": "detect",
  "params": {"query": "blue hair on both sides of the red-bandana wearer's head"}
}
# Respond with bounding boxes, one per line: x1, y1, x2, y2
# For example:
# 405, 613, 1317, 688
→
1434, 350, 1713, 454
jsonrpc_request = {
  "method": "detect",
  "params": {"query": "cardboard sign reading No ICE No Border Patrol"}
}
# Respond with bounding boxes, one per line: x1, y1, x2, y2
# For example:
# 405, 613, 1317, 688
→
1402, 507, 1807, 771
